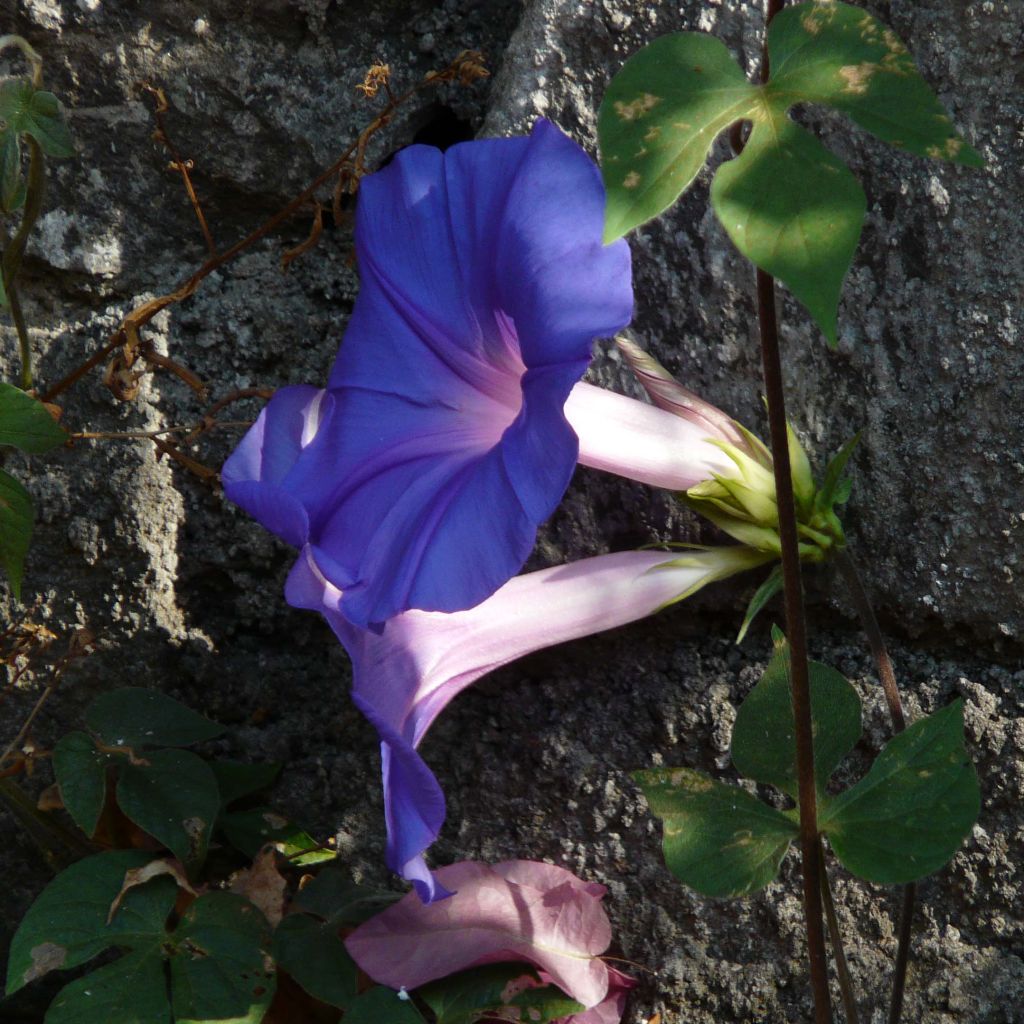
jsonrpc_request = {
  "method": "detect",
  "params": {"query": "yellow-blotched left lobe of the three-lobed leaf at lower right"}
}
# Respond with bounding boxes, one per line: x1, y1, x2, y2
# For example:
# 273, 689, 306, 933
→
633, 768, 797, 896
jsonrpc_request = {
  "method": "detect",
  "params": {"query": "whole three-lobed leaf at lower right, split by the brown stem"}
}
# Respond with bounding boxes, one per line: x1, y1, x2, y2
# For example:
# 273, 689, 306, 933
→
634, 640, 979, 896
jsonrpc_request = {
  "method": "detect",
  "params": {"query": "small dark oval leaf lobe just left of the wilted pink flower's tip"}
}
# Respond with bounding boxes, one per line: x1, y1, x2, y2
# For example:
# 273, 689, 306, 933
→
273, 913, 358, 1010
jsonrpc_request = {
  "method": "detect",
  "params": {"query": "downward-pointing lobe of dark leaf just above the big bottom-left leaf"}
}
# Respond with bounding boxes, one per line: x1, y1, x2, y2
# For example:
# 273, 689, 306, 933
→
117, 751, 220, 872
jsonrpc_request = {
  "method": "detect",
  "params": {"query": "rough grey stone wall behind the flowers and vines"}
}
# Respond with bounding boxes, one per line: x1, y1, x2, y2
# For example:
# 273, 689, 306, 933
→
0, 0, 1024, 1024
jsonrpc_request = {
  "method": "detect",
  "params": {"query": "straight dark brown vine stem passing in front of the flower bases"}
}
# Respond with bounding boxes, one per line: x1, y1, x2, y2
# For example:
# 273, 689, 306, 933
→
757, 267, 831, 1024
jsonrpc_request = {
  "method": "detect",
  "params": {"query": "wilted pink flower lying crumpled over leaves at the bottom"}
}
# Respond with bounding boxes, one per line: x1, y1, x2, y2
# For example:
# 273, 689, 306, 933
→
345, 860, 618, 1007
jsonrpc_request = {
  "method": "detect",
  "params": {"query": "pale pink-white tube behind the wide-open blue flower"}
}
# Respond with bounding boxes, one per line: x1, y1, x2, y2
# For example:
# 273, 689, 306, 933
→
565, 384, 733, 490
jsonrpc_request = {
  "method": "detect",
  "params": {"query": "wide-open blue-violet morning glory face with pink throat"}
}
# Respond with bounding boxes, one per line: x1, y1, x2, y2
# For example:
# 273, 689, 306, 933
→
222, 120, 633, 629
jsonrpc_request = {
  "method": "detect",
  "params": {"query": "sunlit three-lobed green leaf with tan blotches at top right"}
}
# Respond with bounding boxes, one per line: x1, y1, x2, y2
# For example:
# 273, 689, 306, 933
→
598, 0, 982, 344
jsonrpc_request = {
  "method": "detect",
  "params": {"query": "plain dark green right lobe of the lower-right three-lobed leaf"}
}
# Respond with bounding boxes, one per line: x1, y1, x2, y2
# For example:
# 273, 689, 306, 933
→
819, 700, 981, 885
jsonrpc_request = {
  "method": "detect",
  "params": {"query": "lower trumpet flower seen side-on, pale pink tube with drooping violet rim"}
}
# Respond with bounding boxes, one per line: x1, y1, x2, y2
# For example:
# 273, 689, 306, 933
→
287, 548, 767, 901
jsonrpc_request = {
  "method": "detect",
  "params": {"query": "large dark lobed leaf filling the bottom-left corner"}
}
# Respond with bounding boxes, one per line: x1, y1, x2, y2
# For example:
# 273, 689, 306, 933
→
7, 851, 275, 1024
